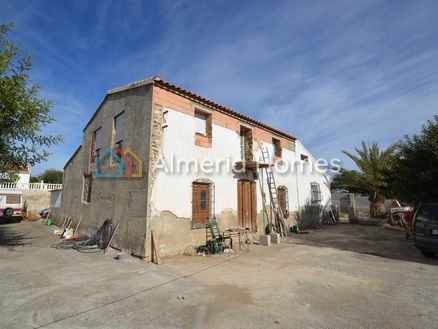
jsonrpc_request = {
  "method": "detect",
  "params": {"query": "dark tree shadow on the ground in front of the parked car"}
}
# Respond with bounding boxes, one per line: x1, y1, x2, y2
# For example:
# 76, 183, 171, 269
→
282, 224, 438, 265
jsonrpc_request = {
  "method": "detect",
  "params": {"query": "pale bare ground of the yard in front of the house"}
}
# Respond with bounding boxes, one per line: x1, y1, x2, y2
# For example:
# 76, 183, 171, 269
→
0, 222, 438, 329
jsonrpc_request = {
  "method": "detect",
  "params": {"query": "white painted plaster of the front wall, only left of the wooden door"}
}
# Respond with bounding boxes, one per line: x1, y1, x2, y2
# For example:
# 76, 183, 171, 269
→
151, 109, 240, 218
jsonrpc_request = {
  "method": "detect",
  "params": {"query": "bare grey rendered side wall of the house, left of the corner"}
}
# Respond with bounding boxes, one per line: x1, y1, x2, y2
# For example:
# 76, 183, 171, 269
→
56, 85, 152, 256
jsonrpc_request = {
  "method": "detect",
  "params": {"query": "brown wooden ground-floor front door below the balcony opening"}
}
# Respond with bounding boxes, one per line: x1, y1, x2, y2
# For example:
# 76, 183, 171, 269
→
237, 180, 257, 232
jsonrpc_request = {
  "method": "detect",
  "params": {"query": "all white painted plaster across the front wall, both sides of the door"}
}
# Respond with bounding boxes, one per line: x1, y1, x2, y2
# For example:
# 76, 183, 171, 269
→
151, 105, 330, 218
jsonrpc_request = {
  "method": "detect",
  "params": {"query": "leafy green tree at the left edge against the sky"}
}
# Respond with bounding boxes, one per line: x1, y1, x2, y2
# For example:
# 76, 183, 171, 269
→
0, 23, 62, 177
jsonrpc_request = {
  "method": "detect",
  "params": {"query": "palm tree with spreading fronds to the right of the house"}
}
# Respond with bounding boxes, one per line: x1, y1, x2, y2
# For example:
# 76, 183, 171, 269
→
337, 142, 396, 217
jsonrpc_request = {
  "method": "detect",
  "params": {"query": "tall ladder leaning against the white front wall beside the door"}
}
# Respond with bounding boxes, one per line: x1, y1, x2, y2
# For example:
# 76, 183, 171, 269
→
262, 147, 287, 236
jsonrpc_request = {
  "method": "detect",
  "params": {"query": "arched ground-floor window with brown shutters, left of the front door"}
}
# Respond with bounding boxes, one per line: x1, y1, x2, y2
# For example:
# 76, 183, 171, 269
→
192, 178, 214, 228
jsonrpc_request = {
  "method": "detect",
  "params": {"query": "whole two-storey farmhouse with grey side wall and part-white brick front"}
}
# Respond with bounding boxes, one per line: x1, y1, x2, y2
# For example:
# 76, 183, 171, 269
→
54, 77, 330, 259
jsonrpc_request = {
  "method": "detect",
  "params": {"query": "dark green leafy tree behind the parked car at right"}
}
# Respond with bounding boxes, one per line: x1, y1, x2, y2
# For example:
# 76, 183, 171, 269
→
389, 115, 438, 205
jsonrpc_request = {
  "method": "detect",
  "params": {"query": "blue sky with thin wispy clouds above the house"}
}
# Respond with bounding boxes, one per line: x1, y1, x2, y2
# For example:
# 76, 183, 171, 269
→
0, 0, 438, 174
